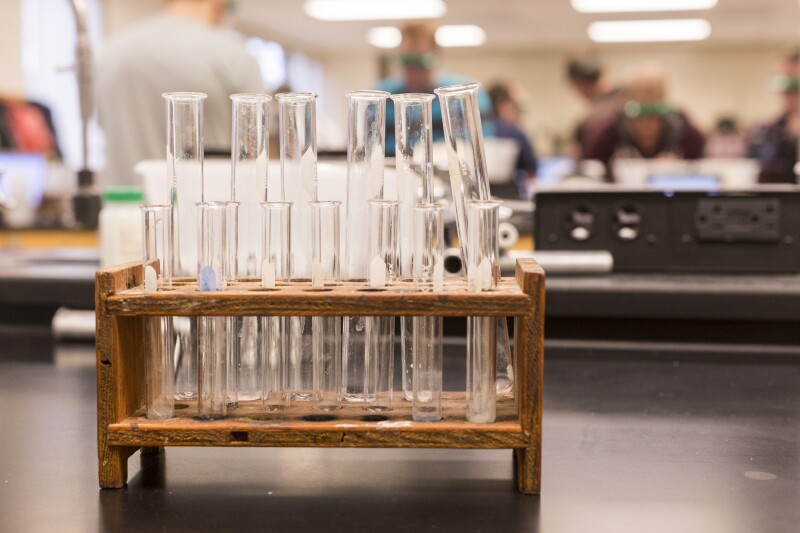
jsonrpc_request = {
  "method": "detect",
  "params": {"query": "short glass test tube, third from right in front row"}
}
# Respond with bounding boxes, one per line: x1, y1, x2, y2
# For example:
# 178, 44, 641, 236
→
364, 200, 398, 412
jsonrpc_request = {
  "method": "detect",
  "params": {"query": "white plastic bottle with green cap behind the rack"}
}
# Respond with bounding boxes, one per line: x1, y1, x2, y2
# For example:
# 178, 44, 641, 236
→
100, 187, 144, 268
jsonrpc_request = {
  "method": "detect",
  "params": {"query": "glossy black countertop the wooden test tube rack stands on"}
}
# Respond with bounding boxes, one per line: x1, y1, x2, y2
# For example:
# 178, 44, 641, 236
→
0, 345, 800, 533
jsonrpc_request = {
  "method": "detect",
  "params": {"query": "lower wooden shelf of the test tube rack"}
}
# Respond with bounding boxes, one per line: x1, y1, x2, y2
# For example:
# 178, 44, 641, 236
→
108, 391, 529, 448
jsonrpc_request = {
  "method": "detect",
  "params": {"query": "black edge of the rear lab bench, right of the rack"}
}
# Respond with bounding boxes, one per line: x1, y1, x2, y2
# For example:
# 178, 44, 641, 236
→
545, 274, 800, 355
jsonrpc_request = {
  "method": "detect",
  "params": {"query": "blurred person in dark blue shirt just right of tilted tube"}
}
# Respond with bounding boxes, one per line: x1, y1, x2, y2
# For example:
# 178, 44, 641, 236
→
489, 83, 537, 198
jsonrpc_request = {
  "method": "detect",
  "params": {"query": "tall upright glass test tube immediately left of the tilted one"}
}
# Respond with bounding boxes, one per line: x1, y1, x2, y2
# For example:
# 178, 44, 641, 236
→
391, 93, 436, 401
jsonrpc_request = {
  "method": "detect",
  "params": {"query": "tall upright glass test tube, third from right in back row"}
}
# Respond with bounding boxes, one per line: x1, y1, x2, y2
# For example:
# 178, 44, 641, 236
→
342, 91, 394, 402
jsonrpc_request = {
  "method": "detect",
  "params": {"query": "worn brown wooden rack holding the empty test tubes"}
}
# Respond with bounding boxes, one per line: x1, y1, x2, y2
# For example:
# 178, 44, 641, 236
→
95, 260, 545, 494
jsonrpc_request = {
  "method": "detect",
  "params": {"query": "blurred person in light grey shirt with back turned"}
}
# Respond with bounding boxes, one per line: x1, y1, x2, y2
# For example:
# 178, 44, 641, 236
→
95, 0, 264, 186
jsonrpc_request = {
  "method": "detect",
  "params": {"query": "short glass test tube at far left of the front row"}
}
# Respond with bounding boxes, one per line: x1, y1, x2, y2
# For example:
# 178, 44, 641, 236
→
141, 205, 175, 420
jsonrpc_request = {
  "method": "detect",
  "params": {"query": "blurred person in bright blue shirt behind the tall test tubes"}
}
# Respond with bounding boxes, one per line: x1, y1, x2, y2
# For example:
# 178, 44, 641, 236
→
375, 22, 492, 156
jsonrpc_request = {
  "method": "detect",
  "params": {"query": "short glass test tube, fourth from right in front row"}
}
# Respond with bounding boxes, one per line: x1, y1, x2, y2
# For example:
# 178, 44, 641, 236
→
311, 202, 342, 411
